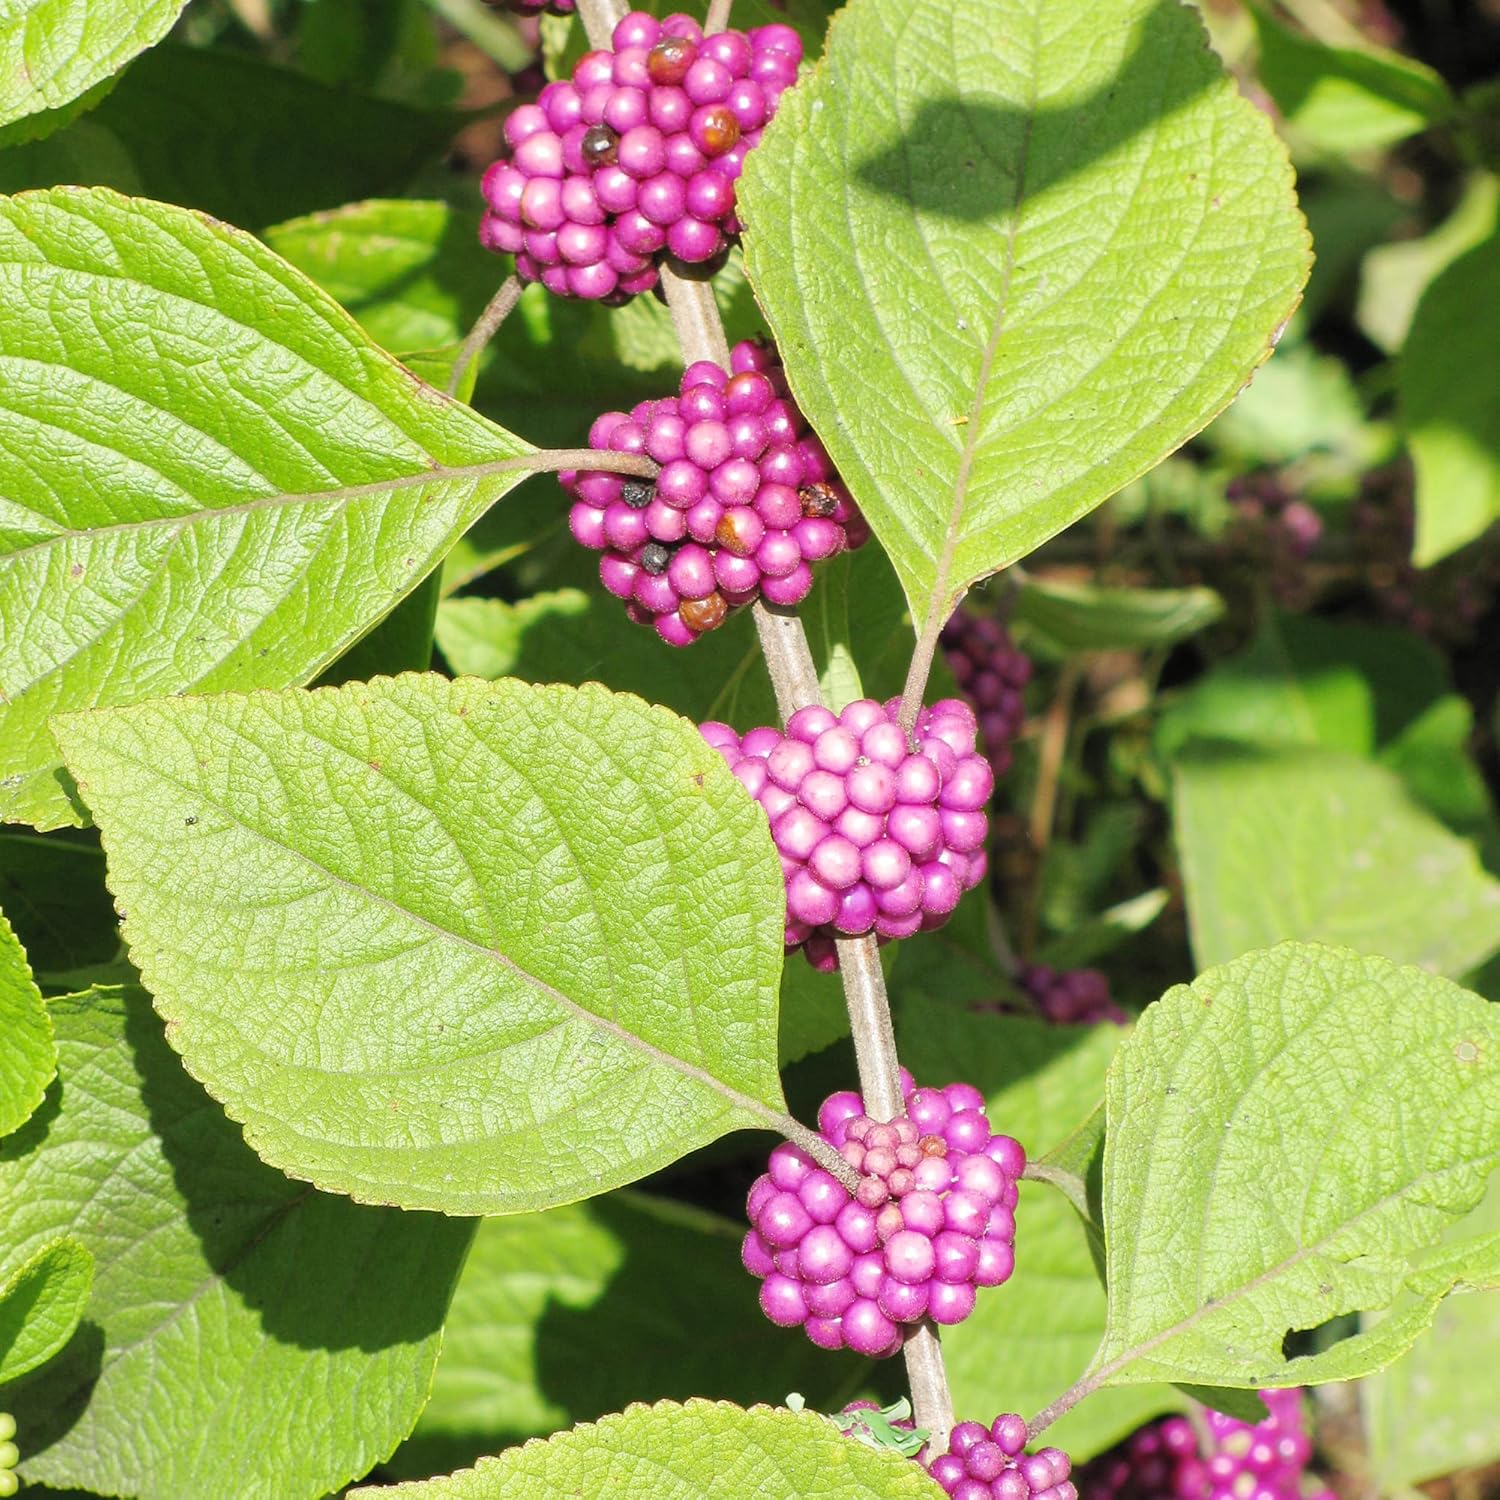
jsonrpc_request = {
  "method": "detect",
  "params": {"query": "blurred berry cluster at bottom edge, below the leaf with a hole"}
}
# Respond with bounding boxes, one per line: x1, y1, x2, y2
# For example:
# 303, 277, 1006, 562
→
1079, 1391, 1334, 1500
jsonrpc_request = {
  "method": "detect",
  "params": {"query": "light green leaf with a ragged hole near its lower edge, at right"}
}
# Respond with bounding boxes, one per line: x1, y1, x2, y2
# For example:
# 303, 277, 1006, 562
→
1092, 944, 1500, 1388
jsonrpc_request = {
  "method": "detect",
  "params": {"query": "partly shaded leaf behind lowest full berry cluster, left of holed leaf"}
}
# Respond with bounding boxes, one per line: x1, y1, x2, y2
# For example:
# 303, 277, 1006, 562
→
897, 998, 1182, 1463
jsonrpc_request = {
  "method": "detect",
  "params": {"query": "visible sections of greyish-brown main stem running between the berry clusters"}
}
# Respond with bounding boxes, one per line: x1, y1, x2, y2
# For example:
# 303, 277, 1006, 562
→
578, 0, 953, 1452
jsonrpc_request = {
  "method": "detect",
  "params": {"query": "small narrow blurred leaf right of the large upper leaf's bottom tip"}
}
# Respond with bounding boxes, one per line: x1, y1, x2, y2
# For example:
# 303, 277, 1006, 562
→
1014, 578, 1224, 654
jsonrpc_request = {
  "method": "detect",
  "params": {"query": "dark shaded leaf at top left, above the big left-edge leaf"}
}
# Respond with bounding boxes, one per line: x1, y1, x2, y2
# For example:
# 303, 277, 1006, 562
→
0, 45, 465, 228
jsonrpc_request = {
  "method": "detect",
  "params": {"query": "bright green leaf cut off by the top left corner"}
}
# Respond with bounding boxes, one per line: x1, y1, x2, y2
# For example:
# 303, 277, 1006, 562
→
0, 0, 188, 125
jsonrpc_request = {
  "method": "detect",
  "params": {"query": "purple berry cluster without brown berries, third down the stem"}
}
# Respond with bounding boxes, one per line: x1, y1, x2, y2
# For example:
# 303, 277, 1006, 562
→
701, 698, 995, 971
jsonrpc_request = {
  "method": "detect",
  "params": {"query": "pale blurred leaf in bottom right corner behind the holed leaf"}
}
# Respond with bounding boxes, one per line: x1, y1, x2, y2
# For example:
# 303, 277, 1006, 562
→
1359, 1184, 1500, 1493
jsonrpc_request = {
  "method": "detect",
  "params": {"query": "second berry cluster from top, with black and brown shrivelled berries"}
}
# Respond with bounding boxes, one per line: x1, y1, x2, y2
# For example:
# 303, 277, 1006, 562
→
558, 339, 870, 647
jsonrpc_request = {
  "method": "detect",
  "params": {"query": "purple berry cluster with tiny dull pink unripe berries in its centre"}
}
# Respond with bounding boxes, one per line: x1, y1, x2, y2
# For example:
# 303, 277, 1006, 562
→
741, 1070, 1026, 1359
